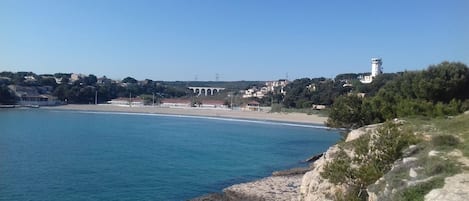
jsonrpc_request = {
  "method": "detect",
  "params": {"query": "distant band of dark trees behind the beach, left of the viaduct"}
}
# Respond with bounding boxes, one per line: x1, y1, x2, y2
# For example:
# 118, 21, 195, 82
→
0, 72, 266, 105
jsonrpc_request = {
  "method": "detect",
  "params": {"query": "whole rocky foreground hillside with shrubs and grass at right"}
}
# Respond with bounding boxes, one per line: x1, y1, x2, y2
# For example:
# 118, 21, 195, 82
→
299, 112, 469, 201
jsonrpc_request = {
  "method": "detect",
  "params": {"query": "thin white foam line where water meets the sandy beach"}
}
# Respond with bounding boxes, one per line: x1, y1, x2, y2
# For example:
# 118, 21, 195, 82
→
55, 110, 330, 130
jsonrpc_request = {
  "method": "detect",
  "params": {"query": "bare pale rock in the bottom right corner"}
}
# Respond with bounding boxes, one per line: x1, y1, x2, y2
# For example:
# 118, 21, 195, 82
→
425, 173, 469, 201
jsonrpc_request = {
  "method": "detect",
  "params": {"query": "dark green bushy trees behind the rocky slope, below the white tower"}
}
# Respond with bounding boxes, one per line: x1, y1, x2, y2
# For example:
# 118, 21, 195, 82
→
327, 62, 469, 128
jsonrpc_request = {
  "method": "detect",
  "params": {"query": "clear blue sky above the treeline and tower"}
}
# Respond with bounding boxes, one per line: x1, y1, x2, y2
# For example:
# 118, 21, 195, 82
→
0, 0, 469, 80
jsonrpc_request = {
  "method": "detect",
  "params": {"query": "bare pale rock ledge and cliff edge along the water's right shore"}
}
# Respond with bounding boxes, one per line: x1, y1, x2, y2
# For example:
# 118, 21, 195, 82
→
190, 125, 376, 201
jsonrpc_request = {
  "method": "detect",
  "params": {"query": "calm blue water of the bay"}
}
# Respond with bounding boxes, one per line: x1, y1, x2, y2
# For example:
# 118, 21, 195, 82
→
0, 109, 339, 201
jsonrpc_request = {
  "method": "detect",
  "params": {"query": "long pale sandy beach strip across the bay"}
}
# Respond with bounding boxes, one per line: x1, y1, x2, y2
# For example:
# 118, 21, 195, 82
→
41, 104, 327, 125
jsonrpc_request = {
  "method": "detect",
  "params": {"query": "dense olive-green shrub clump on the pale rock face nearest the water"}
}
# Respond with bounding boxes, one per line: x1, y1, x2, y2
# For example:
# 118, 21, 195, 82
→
321, 122, 420, 200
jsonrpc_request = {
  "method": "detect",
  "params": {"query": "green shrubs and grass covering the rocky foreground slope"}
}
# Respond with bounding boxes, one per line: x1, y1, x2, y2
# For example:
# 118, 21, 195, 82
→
321, 114, 469, 200
